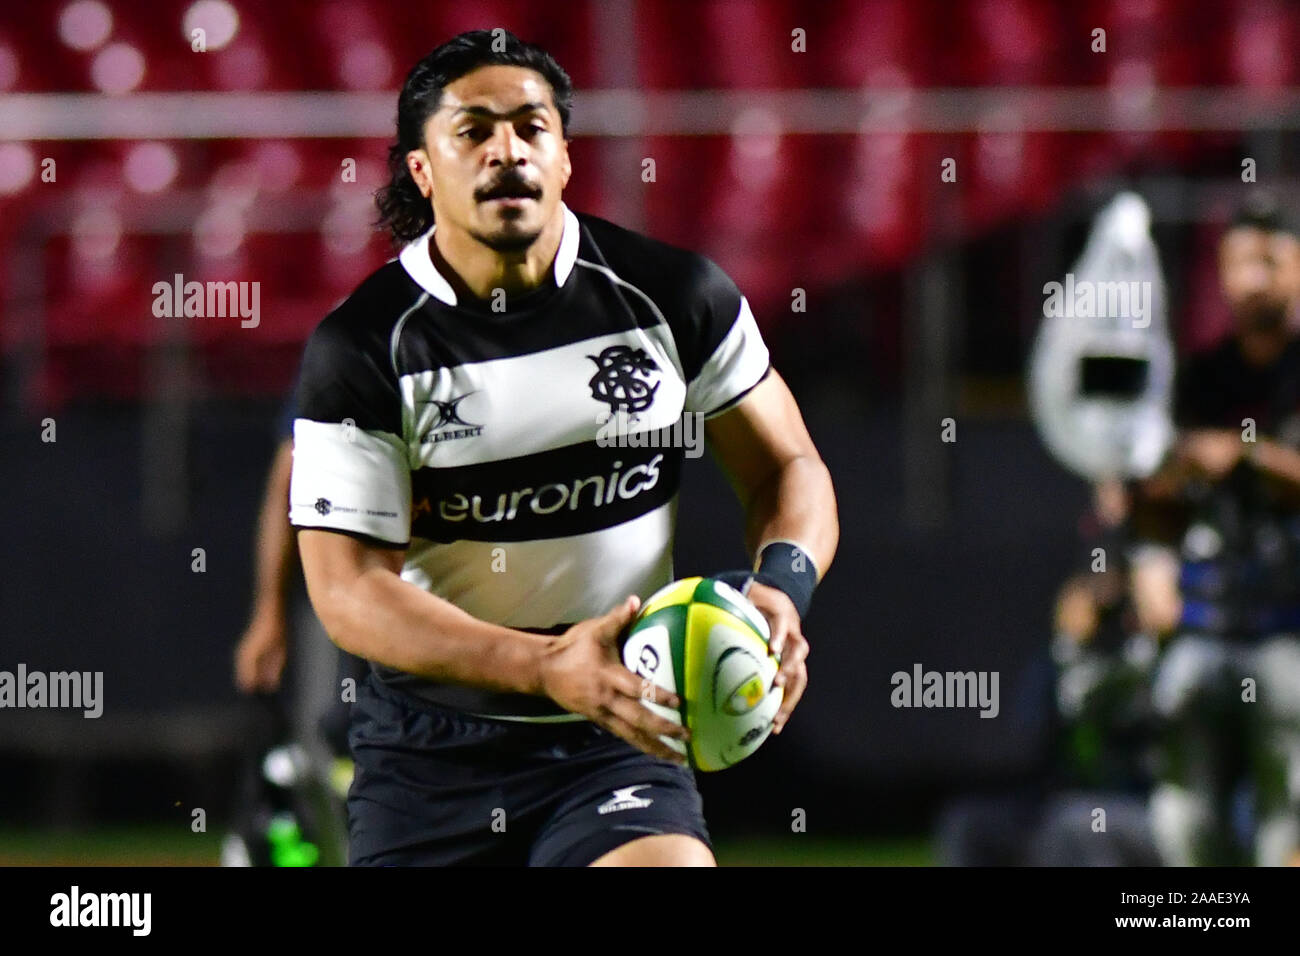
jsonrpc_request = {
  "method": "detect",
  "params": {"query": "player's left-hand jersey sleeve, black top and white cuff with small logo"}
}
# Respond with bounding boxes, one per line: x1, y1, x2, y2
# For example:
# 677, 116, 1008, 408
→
289, 316, 411, 548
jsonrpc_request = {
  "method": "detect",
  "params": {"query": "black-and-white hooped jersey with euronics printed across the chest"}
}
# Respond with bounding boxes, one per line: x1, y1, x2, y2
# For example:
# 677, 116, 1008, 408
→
290, 207, 770, 721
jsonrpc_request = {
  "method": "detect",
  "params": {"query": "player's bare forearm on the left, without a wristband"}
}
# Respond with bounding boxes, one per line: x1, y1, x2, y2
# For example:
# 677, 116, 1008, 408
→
308, 567, 554, 695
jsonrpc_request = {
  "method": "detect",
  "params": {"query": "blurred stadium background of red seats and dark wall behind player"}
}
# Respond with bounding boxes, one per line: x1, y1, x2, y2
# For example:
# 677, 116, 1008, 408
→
0, 0, 1300, 864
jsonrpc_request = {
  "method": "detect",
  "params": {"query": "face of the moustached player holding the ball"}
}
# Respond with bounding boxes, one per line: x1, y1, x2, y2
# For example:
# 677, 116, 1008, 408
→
407, 65, 572, 252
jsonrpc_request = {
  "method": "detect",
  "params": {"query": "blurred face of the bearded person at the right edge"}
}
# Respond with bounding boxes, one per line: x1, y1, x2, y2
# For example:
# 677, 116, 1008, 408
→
1219, 226, 1300, 329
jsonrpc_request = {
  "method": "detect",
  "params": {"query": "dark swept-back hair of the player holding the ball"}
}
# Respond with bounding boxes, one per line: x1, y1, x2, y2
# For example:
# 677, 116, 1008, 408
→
374, 29, 573, 246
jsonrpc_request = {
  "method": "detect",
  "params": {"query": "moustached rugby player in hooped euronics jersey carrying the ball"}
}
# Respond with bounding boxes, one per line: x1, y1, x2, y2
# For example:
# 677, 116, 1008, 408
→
290, 30, 839, 865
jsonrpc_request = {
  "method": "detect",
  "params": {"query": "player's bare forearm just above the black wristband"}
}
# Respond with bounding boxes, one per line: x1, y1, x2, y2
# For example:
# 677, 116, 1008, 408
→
745, 455, 840, 580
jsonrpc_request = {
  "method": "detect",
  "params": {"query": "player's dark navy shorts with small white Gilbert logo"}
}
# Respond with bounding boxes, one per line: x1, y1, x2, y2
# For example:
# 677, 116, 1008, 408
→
347, 674, 712, 866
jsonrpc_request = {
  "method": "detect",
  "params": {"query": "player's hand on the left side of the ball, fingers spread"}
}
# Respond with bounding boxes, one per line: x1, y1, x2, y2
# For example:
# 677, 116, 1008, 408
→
542, 594, 690, 765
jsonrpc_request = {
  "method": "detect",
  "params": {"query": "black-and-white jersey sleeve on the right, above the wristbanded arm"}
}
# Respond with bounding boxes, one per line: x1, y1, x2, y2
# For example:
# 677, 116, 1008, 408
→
685, 259, 771, 419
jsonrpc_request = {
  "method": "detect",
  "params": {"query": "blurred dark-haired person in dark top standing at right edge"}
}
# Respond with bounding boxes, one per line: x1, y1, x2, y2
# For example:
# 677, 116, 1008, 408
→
1132, 198, 1300, 865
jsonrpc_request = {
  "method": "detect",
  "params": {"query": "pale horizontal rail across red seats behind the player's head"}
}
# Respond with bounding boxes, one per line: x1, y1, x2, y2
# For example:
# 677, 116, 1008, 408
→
0, 86, 1300, 140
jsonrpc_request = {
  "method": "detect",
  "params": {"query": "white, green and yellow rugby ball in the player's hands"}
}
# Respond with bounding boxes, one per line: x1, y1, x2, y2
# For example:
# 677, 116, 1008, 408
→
623, 578, 784, 770
